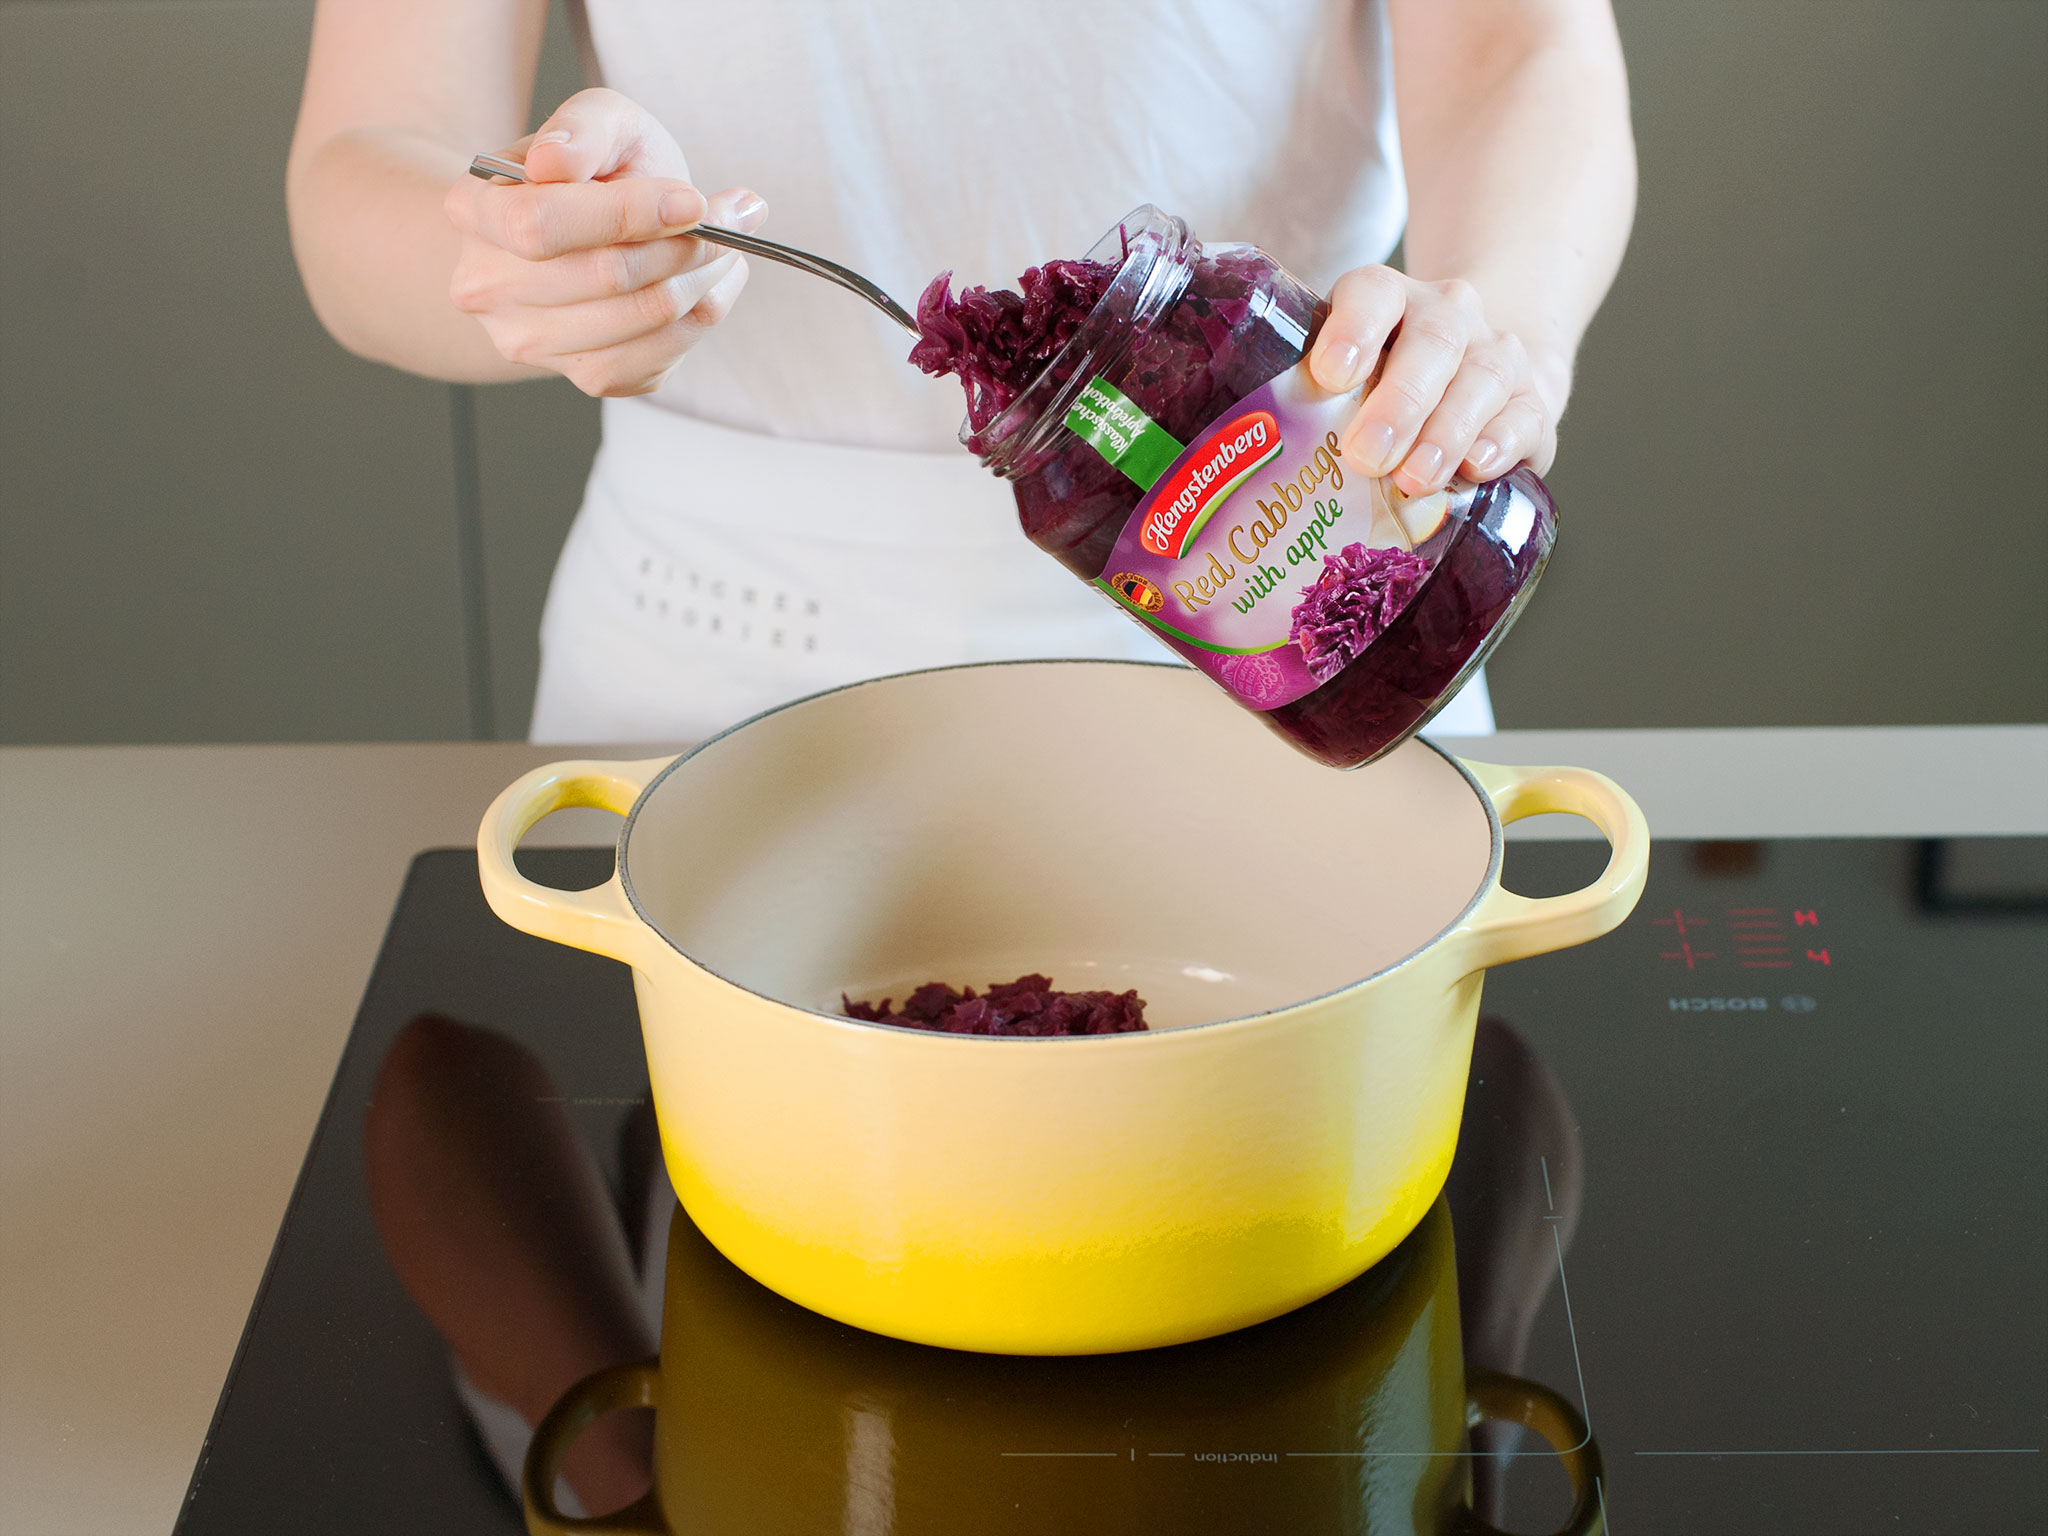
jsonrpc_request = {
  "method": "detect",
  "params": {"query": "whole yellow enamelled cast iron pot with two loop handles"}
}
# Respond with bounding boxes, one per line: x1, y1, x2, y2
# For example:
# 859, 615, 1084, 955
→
477, 662, 1649, 1354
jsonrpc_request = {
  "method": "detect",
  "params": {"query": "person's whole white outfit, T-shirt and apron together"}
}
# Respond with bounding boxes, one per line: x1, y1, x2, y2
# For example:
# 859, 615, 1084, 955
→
532, 0, 1491, 741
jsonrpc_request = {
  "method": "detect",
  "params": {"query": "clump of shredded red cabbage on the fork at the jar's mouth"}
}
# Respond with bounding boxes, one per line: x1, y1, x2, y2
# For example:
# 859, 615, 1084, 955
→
909, 260, 1116, 432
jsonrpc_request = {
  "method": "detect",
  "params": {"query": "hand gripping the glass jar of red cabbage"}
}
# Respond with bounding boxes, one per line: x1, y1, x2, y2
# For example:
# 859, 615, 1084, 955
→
1309, 266, 1571, 496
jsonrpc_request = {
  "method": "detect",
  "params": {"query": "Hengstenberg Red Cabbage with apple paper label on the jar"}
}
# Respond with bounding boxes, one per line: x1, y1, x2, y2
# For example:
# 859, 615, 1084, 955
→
1067, 360, 1468, 709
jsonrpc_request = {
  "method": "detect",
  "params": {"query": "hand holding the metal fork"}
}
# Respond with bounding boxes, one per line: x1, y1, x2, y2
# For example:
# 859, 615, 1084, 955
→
446, 90, 768, 395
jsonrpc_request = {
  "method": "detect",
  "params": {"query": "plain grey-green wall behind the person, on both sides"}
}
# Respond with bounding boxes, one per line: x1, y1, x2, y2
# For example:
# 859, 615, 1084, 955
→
0, 0, 2048, 741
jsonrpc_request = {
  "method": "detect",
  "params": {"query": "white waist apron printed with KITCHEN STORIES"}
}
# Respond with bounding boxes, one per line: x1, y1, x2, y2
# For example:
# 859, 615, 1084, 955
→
532, 399, 1165, 741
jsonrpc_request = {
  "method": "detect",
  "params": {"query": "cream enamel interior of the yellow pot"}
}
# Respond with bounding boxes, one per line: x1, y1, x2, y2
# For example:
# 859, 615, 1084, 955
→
623, 664, 1493, 1047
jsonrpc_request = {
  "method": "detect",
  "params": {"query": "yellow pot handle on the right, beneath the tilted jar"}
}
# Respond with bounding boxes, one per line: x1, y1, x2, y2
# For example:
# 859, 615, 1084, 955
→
1452, 762, 1651, 973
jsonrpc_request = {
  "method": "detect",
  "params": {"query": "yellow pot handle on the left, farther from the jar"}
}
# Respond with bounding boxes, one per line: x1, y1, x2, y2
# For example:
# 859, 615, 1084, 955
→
477, 758, 674, 965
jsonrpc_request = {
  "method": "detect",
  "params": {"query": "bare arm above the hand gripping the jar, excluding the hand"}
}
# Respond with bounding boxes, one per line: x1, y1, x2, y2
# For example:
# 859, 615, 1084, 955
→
1393, 0, 1636, 412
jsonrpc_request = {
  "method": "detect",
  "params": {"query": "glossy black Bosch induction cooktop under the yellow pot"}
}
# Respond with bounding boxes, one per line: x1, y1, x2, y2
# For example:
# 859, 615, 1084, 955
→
178, 838, 2048, 1536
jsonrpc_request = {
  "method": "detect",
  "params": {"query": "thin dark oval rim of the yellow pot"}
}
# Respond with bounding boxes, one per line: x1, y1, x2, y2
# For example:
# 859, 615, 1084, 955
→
612, 655, 1503, 1047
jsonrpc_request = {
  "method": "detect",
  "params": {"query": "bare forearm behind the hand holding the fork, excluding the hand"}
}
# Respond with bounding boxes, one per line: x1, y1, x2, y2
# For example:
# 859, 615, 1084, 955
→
287, 129, 541, 383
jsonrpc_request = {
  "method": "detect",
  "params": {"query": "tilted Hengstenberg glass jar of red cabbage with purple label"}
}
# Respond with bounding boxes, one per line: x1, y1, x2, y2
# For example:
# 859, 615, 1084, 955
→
961, 207, 1556, 768
